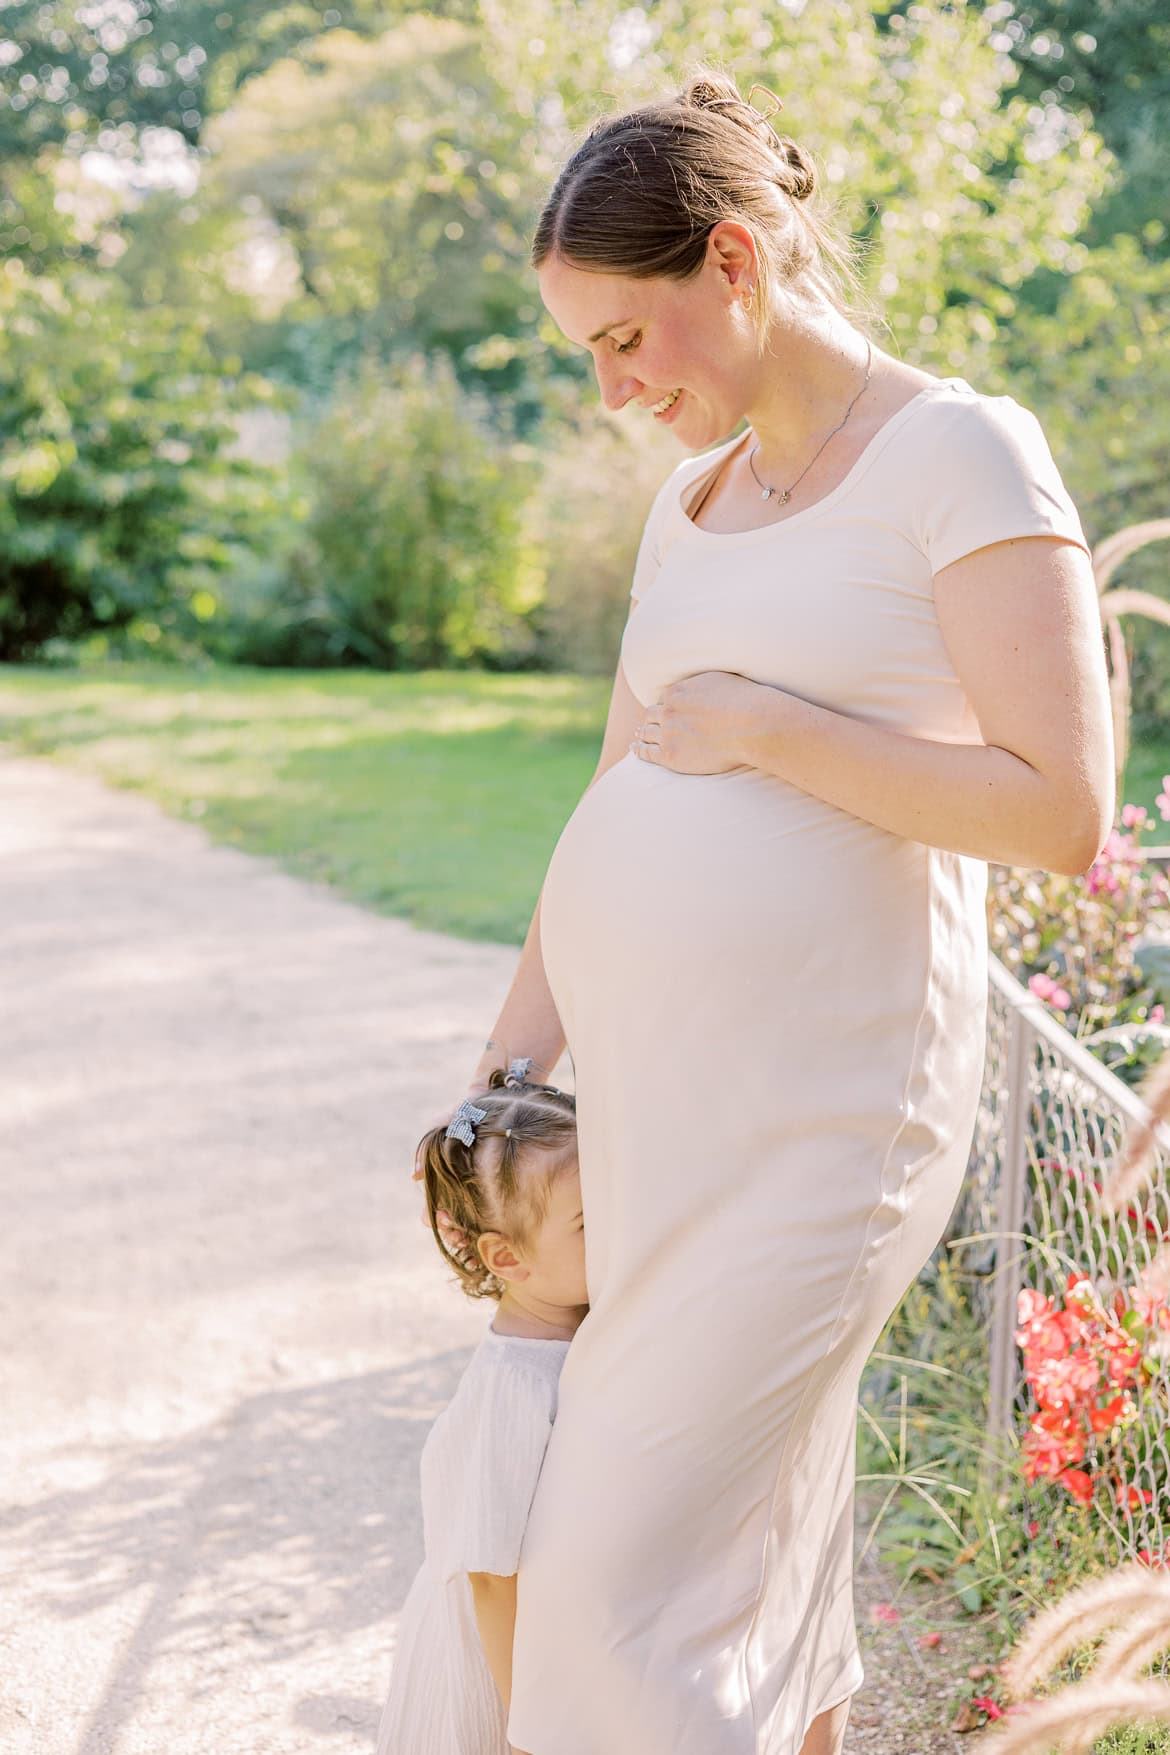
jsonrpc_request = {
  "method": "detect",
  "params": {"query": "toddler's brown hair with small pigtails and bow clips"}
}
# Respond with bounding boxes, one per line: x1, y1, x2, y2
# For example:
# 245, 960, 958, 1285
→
417, 1067, 577, 1299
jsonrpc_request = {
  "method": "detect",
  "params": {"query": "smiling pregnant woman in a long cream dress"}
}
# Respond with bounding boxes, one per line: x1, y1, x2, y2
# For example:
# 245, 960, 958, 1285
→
433, 72, 1114, 1755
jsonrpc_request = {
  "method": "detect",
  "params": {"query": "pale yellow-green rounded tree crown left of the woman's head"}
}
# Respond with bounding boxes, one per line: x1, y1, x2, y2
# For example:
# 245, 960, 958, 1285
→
202, 16, 539, 376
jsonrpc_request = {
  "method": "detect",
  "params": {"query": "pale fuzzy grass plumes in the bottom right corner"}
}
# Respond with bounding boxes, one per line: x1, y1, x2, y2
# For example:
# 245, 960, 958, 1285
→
988, 1562, 1170, 1755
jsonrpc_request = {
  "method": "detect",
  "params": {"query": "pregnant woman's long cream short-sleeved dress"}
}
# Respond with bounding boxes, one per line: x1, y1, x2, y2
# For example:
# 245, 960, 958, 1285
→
508, 379, 1086, 1755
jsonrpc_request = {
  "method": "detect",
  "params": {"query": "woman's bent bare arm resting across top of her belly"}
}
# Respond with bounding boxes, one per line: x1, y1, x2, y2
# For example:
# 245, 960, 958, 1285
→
722, 535, 1116, 876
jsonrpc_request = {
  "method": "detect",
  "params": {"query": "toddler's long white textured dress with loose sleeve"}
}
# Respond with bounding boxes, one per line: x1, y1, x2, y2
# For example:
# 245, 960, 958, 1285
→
377, 1329, 570, 1755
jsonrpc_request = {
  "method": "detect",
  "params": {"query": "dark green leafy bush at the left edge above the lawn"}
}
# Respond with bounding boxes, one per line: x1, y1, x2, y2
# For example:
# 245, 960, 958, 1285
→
0, 270, 284, 660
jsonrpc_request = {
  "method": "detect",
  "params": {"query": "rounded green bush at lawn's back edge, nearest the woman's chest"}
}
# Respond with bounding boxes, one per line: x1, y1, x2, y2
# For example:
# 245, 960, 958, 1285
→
228, 355, 544, 670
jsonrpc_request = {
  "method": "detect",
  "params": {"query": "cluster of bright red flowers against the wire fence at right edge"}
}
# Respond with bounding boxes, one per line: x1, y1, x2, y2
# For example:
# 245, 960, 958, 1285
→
1016, 1269, 1170, 1511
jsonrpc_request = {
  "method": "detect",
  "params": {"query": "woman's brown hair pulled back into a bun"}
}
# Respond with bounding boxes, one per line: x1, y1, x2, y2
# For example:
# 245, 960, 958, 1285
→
531, 63, 872, 340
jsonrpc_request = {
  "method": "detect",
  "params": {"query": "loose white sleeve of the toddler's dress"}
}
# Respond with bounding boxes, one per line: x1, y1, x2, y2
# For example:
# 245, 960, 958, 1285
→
432, 1365, 556, 1583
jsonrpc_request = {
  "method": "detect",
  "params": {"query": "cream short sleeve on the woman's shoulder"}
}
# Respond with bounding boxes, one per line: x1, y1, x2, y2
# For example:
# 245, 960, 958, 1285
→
914, 395, 1091, 572
